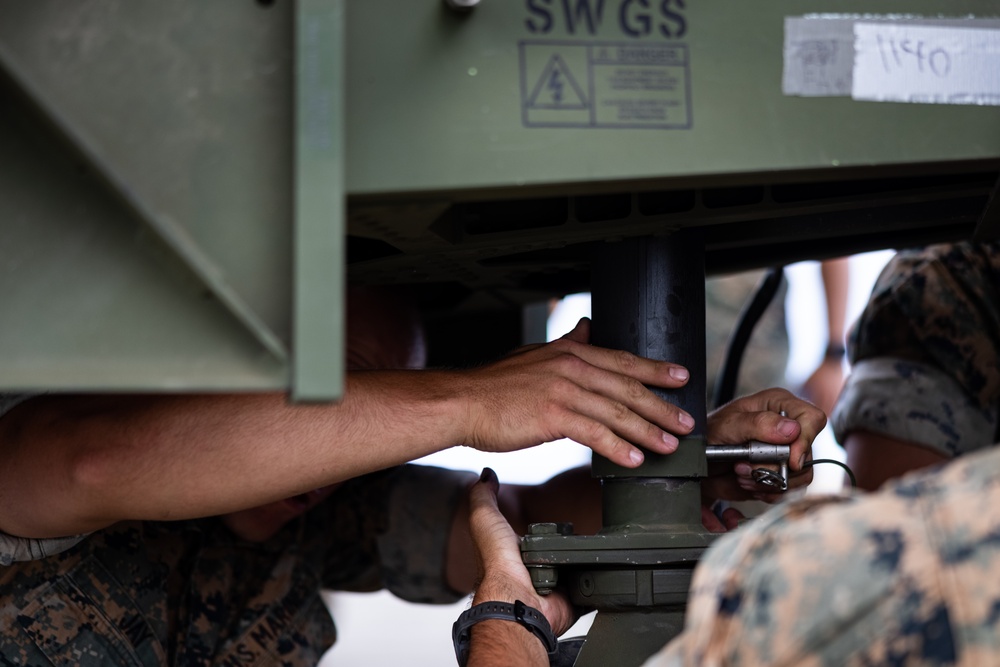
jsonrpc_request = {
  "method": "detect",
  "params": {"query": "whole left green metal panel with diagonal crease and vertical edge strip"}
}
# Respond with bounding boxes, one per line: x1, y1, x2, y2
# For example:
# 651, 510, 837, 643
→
0, 0, 344, 400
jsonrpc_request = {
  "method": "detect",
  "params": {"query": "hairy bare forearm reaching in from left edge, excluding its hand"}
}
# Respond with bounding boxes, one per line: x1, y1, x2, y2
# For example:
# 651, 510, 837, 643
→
0, 371, 464, 537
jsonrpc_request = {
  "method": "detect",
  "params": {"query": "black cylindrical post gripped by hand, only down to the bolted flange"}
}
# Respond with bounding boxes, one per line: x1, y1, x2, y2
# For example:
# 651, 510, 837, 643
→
592, 229, 706, 528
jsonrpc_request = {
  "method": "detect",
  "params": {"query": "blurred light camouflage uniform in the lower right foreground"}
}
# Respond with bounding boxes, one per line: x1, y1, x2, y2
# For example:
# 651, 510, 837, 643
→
646, 449, 1000, 667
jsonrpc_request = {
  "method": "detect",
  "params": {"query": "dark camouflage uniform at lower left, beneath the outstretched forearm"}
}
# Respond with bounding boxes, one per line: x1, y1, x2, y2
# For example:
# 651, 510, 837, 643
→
0, 396, 475, 667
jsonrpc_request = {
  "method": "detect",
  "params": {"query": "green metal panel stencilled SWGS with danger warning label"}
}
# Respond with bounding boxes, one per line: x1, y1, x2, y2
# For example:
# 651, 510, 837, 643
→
347, 0, 1000, 197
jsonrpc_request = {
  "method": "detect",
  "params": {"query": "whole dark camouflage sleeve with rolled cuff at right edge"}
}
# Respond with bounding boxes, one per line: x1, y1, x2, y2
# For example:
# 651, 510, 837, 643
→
832, 243, 1000, 457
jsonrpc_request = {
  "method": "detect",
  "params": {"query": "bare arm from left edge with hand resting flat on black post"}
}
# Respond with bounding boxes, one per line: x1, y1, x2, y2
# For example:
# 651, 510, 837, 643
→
0, 322, 694, 537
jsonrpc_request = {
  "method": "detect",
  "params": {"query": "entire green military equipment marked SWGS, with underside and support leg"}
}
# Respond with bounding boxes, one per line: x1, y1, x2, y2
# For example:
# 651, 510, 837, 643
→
0, 0, 1000, 665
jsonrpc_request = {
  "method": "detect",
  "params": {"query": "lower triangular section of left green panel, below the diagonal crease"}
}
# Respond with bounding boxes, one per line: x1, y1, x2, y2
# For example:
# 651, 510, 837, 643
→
0, 88, 287, 391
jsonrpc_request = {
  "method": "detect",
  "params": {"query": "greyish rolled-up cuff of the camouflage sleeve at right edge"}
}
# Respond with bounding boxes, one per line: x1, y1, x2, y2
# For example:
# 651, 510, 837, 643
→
830, 357, 997, 458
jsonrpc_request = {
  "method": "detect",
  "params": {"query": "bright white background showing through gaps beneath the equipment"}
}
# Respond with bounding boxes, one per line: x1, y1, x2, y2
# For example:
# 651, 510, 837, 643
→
320, 250, 893, 667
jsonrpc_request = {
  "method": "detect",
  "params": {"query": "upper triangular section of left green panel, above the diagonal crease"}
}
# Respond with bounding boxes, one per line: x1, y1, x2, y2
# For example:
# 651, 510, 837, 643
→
0, 0, 293, 356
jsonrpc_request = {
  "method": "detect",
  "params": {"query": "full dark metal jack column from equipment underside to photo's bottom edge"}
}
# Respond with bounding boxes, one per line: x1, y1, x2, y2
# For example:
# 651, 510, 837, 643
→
574, 230, 707, 667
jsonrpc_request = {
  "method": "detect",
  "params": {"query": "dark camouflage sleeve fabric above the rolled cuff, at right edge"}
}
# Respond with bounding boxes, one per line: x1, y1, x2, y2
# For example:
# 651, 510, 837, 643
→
850, 243, 1000, 418
